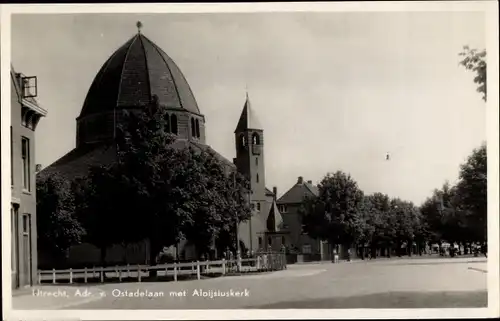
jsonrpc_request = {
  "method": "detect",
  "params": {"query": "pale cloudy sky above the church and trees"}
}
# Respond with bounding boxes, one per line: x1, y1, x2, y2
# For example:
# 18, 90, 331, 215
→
12, 12, 486, 204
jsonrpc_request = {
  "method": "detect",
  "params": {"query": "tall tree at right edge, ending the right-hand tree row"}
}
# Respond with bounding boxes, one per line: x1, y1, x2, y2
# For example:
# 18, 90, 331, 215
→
455, 143, 488, 241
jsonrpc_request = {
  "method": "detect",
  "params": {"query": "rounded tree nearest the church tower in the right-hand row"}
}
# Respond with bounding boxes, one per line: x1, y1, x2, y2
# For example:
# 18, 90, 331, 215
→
301, 171, 364, 245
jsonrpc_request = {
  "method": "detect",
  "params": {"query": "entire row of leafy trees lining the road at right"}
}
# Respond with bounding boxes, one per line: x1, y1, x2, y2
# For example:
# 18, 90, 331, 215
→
301, 145, 487, 255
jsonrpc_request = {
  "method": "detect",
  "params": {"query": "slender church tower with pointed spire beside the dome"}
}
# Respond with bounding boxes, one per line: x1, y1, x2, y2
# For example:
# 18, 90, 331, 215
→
234, 93, 269, 251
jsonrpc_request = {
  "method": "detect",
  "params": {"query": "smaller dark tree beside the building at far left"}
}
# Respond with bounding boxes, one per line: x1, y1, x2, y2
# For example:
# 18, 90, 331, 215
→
36, 174, 85, 263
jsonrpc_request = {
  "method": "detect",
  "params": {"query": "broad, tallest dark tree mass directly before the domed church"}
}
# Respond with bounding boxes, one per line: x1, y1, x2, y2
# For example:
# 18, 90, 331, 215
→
80, 98, 254, 264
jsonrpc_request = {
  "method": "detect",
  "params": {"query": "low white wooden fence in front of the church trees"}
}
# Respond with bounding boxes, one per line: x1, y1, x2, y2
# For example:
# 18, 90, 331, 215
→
38, 253, 286, 284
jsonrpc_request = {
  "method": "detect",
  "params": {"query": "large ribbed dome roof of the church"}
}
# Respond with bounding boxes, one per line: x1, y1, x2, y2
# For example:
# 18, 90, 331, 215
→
79, 32, 200, 118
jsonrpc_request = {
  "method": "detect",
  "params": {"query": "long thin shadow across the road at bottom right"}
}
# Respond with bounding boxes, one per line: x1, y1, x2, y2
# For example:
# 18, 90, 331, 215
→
248, 291, 488, 309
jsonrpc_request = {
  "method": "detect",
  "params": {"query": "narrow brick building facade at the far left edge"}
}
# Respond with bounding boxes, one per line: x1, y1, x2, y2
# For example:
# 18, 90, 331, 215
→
10, 68, 47, 289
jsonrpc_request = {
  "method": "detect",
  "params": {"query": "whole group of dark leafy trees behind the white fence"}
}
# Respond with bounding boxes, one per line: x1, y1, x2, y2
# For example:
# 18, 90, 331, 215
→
37, 102, 251, 264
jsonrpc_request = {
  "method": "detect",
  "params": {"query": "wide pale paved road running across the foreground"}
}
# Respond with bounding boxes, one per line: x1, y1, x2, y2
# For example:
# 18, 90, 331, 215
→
14, 258, 487, 309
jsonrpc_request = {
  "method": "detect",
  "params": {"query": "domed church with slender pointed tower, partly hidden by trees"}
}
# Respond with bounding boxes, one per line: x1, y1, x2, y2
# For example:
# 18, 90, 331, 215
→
40, 24, 284, 264
